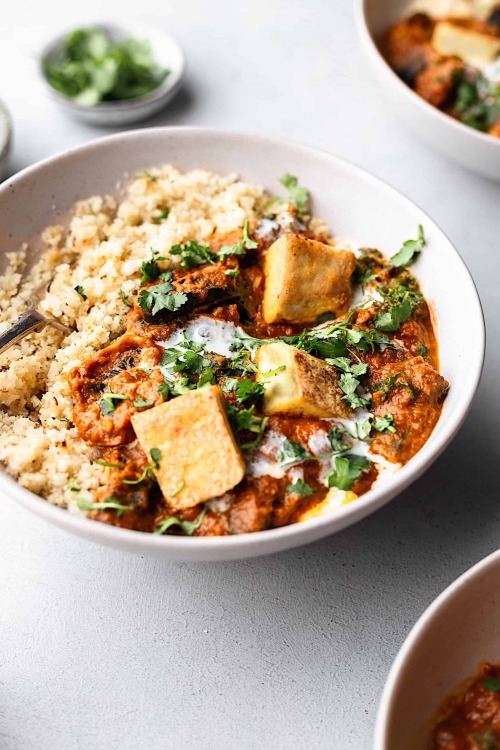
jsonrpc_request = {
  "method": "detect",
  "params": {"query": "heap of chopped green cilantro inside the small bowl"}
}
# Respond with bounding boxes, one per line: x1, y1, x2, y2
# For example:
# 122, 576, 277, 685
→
44, 28, 170, 107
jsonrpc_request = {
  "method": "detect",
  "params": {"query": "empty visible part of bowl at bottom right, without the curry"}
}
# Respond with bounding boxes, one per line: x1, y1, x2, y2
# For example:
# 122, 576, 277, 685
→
374, 551, 500, 750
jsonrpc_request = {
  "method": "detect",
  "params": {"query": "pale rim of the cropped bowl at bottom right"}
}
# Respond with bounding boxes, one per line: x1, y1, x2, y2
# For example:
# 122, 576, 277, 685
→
374, 549, 500, 750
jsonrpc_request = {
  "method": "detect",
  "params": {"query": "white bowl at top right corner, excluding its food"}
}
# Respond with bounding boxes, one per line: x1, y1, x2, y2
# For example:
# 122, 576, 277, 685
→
355, 0, 500, 180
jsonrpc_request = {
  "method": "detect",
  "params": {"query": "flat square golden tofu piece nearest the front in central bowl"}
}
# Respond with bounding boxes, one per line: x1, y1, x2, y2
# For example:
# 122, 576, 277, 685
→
132, 385, 245, 510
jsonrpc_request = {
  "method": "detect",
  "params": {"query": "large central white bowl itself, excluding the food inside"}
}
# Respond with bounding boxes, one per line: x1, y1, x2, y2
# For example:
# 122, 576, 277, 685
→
0, 128, 484, 560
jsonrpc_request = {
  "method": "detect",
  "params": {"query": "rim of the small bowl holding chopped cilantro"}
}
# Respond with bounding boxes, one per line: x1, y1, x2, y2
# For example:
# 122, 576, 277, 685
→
37, 19, 186, 115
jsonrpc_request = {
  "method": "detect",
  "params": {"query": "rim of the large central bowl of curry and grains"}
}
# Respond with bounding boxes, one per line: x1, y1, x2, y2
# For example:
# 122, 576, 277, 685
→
0, 126, 486, 559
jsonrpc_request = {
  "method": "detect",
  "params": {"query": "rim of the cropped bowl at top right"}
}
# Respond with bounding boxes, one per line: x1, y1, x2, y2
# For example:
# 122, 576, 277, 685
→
354, 0, 500, 149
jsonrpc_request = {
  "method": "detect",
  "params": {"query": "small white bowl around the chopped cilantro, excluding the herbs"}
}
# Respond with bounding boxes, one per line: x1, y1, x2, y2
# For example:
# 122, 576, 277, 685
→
40, 23, 186, 127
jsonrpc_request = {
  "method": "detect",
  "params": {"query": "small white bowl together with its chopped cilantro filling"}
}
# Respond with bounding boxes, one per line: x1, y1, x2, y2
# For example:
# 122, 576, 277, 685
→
41, 24, 184, 125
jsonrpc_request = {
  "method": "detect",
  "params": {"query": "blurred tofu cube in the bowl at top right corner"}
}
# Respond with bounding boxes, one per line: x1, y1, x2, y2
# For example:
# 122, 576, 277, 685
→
431, 21, 500, 68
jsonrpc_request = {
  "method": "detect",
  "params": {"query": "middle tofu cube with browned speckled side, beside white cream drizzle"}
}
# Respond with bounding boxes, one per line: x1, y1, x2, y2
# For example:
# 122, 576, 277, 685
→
256, 341, 351, 418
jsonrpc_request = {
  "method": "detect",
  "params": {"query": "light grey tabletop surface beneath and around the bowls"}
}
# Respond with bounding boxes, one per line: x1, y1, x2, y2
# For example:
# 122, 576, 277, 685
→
0, 0, 500, 750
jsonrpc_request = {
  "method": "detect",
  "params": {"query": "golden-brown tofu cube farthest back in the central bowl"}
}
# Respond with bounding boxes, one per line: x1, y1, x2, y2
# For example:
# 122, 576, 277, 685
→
262, 234, 355, 323
